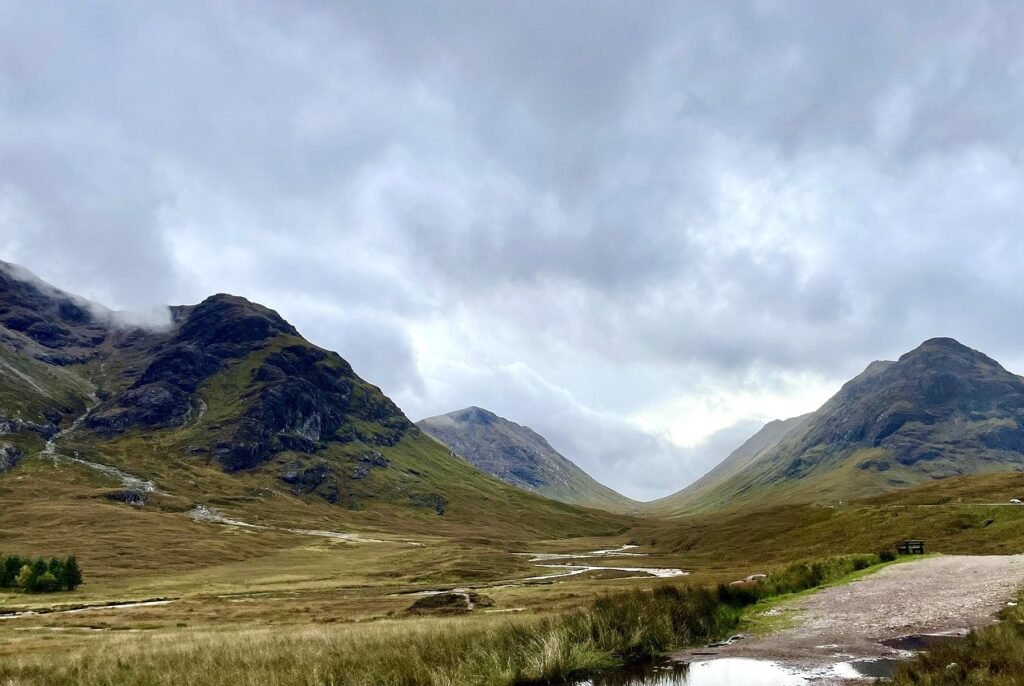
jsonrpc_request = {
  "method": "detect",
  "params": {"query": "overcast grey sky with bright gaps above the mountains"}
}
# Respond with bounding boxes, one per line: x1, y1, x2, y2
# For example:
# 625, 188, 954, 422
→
0, 0, 1024, 500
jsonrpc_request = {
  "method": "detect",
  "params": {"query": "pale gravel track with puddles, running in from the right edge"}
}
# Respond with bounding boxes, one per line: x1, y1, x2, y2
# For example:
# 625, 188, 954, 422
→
678, 555, 1024, 669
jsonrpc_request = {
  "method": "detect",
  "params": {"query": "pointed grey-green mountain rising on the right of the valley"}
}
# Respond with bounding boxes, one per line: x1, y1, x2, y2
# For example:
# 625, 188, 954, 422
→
652, 338, 1024, 513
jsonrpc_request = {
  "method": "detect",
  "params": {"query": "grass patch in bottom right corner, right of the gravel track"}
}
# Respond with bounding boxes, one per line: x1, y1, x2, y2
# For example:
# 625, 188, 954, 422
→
892, 592, 1024, 686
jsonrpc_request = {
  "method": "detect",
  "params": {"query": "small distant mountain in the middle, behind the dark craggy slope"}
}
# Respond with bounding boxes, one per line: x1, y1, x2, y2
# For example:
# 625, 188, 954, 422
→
417, 408, 638, 511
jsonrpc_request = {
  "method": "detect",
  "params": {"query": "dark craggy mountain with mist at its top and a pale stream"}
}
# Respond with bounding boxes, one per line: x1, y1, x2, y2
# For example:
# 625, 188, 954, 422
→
0, 262, 622, 538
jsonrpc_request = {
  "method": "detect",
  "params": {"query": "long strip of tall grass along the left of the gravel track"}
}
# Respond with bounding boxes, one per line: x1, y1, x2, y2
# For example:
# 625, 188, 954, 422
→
0, 556, 879, 686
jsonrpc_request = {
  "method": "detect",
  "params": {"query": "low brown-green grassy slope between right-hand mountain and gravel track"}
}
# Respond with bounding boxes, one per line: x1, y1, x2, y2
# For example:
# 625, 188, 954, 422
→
633, 472, 1024, 576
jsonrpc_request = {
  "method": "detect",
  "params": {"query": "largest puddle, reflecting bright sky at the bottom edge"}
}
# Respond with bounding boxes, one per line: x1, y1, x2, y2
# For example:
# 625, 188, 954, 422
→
575, 657, 813, 686
